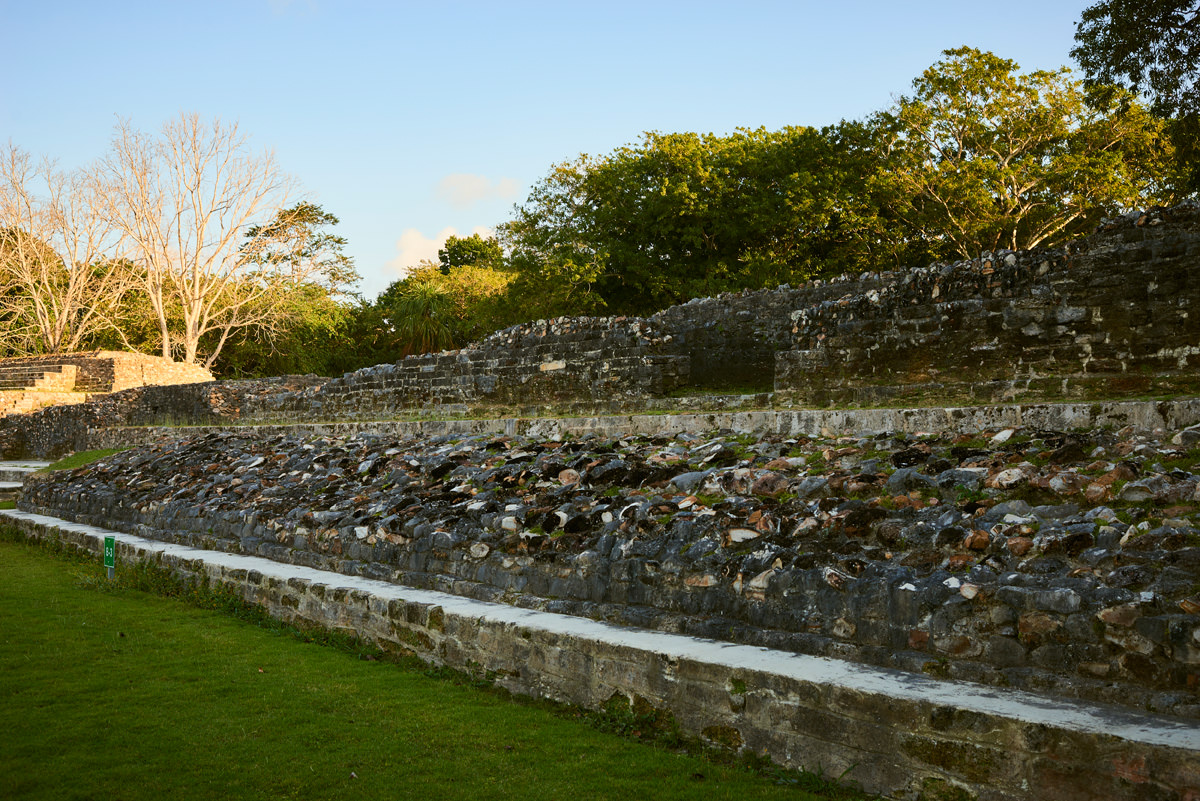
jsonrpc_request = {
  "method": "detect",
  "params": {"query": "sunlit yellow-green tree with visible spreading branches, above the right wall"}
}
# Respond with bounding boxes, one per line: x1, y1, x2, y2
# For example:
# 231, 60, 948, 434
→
872, 48, 1169, 258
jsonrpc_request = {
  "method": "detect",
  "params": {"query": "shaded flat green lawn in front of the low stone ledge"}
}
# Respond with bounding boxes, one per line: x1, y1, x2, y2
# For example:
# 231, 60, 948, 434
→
0, 536, 860, 800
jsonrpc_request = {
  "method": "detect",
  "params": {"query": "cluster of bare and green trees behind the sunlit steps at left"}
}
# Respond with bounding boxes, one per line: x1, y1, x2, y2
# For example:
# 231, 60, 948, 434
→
0, 115, 358, 374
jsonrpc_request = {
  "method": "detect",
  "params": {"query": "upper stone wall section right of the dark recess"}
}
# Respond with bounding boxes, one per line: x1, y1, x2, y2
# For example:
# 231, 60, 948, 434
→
775, 206, 1200, 404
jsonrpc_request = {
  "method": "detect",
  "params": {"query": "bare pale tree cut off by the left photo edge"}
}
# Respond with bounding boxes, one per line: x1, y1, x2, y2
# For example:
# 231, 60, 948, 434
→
0, 143, 130, 353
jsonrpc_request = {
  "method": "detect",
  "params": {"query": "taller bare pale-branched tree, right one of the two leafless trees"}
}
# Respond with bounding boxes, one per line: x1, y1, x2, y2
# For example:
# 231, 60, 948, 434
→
95, 114, 302, 367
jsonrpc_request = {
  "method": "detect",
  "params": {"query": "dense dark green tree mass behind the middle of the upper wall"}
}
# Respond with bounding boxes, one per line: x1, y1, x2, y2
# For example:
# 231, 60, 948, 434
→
499, 127, 864, 313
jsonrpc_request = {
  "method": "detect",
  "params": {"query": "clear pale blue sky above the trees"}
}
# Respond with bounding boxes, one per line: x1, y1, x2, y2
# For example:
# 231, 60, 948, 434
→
0, 0, 1091, 297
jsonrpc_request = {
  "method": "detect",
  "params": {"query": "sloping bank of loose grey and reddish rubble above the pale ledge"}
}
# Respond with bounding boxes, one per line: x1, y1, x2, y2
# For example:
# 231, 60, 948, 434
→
20, 427, 1200, 717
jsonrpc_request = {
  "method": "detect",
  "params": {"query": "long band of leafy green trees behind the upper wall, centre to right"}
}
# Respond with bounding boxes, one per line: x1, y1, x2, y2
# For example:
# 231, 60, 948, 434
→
499, 48, 1170, 317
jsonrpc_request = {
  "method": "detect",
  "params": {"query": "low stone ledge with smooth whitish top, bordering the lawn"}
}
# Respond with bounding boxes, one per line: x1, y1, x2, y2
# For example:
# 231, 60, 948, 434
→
0, 511, 1200, 801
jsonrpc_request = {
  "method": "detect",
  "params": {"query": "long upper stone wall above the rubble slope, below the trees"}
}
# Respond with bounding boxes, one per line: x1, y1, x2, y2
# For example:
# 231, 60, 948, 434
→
0, 206, 1200, 448
